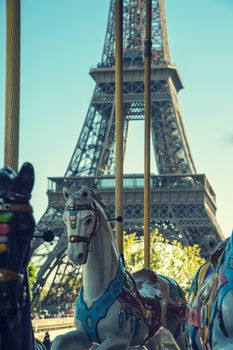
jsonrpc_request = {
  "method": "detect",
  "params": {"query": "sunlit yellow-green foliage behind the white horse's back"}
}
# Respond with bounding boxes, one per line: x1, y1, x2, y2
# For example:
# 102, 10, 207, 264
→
124, 230, 205, 292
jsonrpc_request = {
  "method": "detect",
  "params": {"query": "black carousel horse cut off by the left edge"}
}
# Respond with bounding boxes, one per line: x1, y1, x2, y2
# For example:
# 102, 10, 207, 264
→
0, 163, 45, 350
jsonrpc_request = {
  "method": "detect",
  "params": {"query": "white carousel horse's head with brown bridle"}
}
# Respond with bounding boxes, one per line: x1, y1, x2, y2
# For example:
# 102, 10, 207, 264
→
63, 186, 100, 265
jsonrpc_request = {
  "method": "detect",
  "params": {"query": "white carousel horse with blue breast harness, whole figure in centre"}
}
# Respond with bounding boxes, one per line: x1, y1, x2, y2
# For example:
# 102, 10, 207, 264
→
51, 186, 186, 350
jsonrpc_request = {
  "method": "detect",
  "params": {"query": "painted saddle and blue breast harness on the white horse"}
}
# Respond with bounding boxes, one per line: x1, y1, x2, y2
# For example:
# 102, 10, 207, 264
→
76, 259, 186, 343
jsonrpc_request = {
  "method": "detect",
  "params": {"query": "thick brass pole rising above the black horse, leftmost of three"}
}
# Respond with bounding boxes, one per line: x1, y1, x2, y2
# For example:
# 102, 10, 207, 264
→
4, 0, 20, 171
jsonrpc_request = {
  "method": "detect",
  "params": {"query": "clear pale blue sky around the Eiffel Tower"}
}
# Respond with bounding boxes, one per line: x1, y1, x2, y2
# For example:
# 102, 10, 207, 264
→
0, 0, 233, 235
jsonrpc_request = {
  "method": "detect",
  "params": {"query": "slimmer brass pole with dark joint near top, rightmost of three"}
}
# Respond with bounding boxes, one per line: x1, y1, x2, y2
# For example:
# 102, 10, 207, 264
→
144, 0, 151, 268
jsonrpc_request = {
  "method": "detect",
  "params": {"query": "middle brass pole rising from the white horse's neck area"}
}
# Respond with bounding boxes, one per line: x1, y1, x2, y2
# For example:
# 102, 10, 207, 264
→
115, 0, 123, 254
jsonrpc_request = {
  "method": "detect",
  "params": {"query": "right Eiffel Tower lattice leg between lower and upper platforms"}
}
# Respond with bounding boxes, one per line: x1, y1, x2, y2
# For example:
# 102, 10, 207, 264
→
152, 79, 196, 174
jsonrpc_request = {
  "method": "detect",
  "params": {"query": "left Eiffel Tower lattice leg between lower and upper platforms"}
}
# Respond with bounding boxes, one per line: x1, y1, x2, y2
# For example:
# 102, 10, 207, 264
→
66, 84, 119, 176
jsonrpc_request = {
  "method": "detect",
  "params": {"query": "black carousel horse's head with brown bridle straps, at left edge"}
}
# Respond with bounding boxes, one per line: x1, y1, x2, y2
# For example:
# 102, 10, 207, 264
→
0, 163, 35, 333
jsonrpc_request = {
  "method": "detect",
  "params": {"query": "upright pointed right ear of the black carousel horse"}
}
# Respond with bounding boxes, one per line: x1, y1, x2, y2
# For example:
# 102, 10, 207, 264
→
15, 163, 35, 194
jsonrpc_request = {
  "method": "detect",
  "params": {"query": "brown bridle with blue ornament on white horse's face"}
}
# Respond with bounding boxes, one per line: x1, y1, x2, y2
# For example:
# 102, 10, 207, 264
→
65, 201, 100, 249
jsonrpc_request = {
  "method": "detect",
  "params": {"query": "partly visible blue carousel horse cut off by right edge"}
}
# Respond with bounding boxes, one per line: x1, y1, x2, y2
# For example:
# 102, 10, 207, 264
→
187, 232, 233, 350
